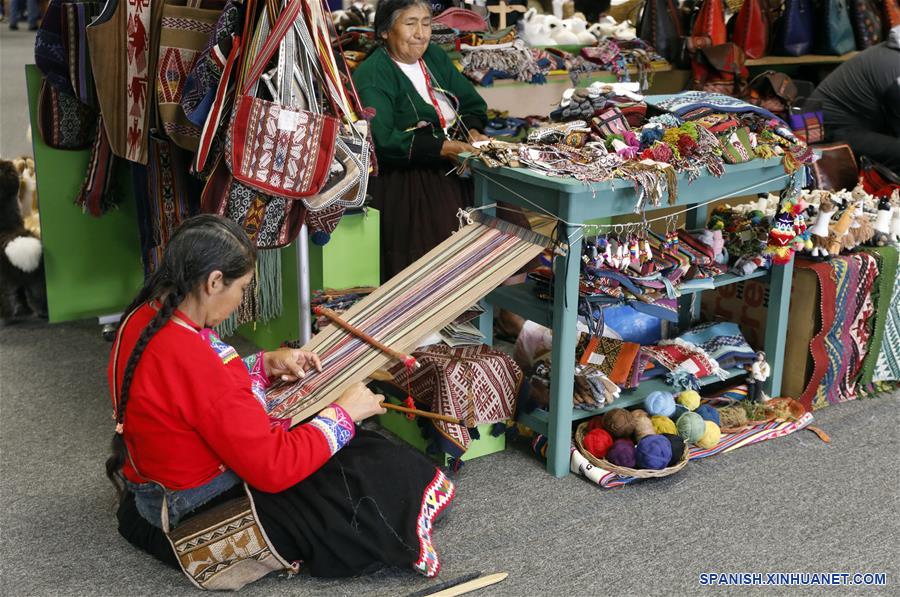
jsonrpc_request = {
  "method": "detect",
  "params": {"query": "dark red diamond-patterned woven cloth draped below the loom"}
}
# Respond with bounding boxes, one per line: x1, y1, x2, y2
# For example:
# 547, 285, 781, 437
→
390, 344, 523, 457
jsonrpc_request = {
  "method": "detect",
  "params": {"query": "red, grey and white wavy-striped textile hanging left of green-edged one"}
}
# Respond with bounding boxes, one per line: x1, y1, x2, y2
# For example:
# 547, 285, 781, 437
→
797, 253, 878, 409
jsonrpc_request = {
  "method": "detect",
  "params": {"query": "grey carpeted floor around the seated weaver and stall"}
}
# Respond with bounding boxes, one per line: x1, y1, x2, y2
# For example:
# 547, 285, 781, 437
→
0, 19, 900, 596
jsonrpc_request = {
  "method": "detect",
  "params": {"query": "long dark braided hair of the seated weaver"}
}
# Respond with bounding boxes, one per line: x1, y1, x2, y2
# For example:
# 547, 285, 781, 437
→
106, 215, 256, 499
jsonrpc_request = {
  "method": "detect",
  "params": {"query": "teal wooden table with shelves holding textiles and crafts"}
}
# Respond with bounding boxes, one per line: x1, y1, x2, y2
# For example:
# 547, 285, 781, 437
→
472, 158, 793, 477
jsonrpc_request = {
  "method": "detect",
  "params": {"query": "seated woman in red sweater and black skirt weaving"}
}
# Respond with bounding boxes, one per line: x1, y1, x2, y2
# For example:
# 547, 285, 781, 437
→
106, 215, 454, 576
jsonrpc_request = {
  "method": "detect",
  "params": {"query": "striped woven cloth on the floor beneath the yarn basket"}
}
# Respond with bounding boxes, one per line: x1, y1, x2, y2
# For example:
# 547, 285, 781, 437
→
570, 413, 813, 489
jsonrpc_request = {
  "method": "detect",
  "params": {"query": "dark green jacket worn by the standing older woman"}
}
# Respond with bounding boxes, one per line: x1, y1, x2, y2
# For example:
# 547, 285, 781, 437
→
353, 44, 487, 166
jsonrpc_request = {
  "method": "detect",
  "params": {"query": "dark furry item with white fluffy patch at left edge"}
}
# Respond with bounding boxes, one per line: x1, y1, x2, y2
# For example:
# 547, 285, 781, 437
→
0, 160, 47, 323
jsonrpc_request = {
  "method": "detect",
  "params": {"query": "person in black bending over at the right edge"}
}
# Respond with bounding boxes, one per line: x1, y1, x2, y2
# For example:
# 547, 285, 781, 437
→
810, 27, 900, 174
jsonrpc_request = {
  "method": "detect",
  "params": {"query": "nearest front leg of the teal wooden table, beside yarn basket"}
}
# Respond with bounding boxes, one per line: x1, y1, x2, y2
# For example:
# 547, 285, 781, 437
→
547, 224, 581, 477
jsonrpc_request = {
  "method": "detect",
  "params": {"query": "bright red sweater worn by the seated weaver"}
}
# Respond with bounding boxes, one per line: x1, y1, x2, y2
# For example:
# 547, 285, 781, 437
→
108, 305, 340, 493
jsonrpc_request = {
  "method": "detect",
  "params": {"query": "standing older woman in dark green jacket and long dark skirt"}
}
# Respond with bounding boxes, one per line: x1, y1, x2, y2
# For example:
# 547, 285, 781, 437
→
353, 0, 487, 280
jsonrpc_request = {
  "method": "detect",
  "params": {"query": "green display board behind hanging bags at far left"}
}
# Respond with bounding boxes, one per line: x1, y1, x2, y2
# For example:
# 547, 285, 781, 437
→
25, 65, 143, 323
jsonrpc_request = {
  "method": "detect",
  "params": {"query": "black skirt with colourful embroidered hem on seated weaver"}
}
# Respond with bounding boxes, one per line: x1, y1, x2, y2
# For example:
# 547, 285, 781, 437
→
118, 429, 454, 577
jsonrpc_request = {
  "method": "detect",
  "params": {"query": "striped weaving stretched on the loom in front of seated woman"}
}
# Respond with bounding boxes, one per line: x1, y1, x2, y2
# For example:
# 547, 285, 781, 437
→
267, 212, 550, 425
